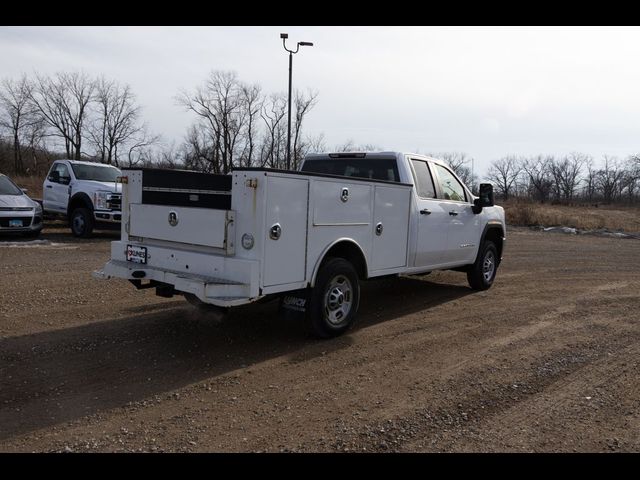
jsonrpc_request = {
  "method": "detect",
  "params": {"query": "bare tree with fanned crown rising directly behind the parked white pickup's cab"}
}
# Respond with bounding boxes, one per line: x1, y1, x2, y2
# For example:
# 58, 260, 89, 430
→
30, 72, 95, 160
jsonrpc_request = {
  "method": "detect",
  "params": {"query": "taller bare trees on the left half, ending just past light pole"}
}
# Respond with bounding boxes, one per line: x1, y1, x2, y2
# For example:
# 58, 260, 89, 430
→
0, 71, 325, 175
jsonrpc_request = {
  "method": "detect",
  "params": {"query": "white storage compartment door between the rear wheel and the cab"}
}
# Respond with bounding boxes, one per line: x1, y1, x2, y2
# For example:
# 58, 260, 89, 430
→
369, 185, 411, 272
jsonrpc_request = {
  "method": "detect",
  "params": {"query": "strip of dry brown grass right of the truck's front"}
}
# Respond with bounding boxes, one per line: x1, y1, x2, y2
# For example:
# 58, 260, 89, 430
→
500, 201, 640, 232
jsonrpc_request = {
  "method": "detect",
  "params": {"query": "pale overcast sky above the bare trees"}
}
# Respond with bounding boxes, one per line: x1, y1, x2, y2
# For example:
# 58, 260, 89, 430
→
0, 26, 640, 173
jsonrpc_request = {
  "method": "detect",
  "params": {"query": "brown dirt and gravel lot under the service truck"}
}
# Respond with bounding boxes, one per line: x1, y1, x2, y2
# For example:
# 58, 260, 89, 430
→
0, 229, 640, 452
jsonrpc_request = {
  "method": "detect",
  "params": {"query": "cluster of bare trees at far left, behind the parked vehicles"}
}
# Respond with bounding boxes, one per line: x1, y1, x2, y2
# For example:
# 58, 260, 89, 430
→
0, 72, 159, 175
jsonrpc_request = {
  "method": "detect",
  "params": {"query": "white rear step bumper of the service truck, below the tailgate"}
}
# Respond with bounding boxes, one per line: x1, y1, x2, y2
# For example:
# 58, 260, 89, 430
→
93, 242, 261, 307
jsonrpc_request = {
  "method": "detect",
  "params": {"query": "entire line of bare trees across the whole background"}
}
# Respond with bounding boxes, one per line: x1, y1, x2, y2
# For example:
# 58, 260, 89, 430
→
0, 71, 640, 203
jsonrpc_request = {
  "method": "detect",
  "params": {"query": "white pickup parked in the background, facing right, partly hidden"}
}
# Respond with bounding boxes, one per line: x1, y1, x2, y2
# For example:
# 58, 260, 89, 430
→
42, 160, 122, 237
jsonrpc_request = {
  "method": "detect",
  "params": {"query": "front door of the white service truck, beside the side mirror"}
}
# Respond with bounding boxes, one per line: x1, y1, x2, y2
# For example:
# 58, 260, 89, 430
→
432, 163, 480, 264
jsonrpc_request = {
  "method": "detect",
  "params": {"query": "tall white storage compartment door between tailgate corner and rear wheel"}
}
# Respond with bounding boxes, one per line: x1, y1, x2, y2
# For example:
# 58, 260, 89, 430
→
263, 176, 309, 287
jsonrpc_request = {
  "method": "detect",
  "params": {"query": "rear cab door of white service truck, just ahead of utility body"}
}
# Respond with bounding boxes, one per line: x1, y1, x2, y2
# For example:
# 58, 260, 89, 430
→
411, 159, 449, 268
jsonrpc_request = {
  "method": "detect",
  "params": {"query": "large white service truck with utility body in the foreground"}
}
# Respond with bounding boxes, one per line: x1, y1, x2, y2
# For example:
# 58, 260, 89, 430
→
94, 152, 506, 337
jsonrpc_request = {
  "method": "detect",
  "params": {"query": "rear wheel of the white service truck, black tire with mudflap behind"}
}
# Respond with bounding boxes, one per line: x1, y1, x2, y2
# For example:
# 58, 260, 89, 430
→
307, 258, 360, 338
